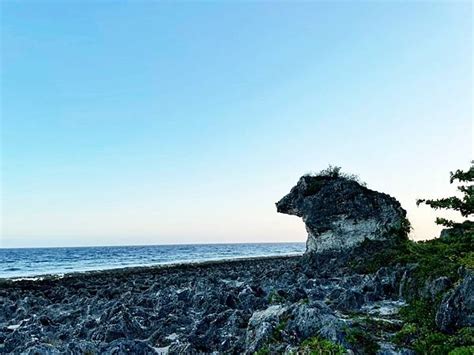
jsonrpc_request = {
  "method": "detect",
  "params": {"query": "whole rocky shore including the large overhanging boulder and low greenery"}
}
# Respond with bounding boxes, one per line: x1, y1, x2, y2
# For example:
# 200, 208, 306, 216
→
0, 170, 474, 355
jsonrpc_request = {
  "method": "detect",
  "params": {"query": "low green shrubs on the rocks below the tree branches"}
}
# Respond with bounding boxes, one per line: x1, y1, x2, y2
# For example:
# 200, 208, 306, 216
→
353, 227, 474, 354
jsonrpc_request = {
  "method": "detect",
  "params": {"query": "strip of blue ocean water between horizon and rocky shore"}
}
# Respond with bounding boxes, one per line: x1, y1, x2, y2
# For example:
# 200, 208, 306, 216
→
0, 243, 305, 278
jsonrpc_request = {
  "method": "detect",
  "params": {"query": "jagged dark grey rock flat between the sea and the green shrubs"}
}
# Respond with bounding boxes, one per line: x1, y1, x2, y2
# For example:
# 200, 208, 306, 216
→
0, 256, 414, 354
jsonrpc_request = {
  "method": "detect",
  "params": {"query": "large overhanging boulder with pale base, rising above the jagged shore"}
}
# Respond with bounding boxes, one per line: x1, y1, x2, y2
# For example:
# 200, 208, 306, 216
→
276, 175, 406, 253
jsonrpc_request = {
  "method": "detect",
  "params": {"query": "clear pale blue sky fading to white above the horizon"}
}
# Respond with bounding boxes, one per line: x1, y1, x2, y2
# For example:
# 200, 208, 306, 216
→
0, 0, 473, 247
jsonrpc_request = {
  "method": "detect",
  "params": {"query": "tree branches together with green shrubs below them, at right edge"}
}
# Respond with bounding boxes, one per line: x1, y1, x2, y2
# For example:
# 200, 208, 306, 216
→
358, 165, 474, 355
